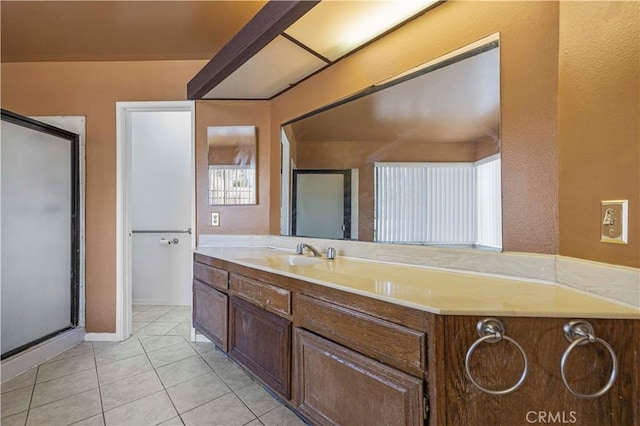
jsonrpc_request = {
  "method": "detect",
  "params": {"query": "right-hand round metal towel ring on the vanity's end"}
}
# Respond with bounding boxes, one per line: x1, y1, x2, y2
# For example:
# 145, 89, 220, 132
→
560, 320, 618, 399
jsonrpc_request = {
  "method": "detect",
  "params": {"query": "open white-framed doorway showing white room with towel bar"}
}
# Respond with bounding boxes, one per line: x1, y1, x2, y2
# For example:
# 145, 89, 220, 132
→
113, 101, 195, 340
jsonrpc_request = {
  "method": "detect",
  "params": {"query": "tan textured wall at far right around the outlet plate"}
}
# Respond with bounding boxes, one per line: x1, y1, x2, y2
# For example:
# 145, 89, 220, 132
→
558, 1, 640, 267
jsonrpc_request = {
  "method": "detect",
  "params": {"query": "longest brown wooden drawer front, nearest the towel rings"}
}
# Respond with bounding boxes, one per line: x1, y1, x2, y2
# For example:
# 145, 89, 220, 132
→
295, 294, 426, 377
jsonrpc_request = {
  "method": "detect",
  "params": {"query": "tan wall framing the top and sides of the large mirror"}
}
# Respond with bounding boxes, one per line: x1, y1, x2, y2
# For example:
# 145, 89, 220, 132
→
270, 1, 559, 253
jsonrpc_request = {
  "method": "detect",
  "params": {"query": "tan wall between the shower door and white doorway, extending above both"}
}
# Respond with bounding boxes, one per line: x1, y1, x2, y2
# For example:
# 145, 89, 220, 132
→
2, 61, 204, 332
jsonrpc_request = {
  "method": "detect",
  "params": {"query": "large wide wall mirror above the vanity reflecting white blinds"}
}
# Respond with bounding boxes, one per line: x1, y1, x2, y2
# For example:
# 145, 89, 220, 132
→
281, 34, 502, 250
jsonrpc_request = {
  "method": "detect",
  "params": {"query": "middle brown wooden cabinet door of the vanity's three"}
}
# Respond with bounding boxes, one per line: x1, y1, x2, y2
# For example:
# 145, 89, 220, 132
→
229, 297, 291, 400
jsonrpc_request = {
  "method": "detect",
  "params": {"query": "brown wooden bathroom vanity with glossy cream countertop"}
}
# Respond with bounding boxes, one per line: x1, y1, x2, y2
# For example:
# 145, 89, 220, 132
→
193, 248, 640, 426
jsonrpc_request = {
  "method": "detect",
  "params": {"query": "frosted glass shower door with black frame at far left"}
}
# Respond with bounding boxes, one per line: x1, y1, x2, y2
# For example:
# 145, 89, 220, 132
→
0, 110, 79, 359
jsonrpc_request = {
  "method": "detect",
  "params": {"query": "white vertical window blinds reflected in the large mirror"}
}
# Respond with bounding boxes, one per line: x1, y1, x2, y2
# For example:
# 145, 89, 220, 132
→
375, 155, 502, 248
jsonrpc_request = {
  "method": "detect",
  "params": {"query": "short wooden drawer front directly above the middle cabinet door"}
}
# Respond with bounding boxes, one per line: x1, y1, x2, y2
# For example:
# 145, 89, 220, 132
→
229, 274, 291, 315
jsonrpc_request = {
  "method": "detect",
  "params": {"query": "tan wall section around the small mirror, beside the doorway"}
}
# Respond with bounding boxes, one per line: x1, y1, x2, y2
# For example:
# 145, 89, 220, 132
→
196, 101, 270, 235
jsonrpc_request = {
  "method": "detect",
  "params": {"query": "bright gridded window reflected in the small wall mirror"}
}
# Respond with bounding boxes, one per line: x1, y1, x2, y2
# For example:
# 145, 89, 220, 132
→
209, 165, 256, 205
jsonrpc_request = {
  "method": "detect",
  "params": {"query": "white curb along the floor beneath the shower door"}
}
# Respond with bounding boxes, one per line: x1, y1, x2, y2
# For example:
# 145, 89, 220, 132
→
2, 327, 86, 382
